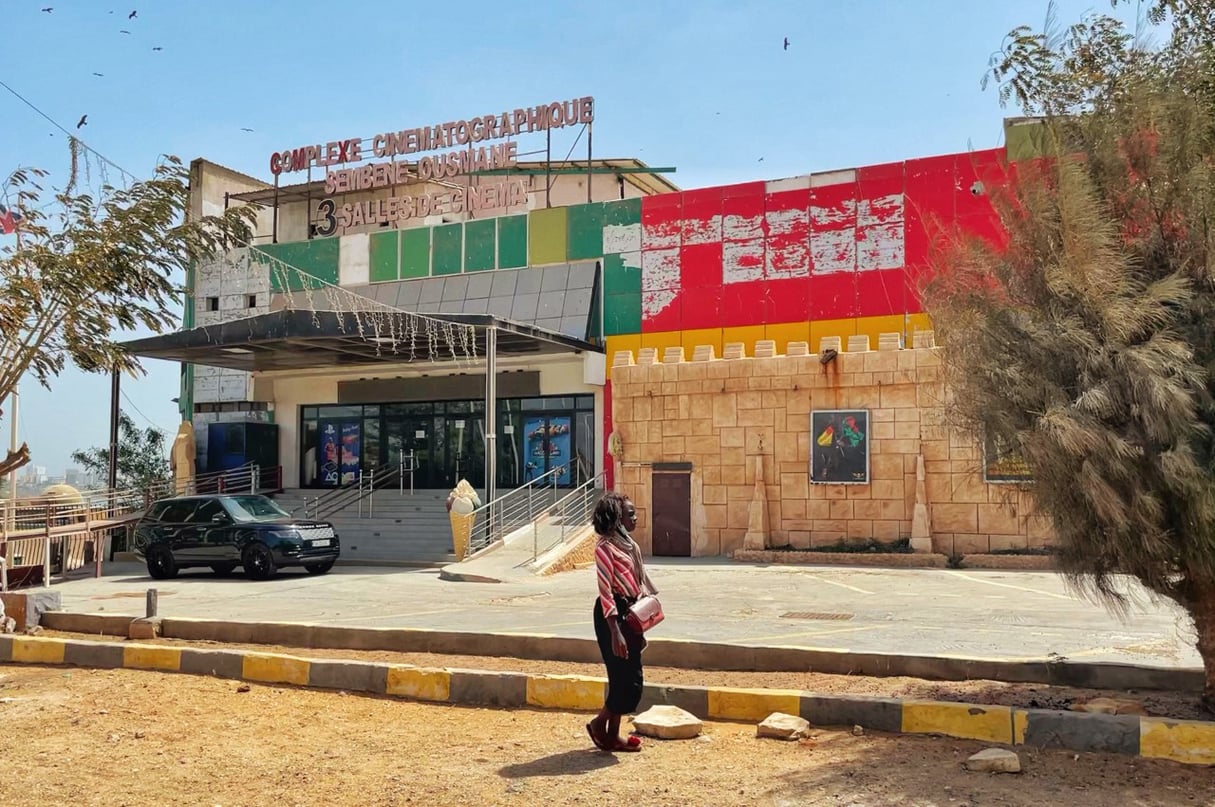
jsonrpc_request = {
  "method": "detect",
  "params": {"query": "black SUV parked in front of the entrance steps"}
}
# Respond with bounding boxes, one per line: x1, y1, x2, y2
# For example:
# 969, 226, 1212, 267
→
134, 495, 340, 580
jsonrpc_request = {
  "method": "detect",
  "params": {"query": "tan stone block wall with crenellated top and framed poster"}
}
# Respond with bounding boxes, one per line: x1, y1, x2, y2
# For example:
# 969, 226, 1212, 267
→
612, 332, 1052, 555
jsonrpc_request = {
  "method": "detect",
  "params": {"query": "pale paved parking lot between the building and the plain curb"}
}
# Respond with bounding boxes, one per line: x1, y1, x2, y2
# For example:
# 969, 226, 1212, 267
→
47, 559, 1200, 667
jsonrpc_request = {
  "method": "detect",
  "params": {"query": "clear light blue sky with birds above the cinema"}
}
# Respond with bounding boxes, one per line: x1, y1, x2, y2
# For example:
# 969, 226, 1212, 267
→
0, 0, 1135, 473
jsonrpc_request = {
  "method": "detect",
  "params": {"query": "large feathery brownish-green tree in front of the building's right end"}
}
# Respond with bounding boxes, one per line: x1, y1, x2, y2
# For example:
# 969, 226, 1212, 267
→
925, 0, 1215, 709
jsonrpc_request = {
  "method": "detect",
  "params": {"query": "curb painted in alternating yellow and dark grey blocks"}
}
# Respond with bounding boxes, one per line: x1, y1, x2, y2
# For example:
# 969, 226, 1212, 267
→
0, 636, 1215, 764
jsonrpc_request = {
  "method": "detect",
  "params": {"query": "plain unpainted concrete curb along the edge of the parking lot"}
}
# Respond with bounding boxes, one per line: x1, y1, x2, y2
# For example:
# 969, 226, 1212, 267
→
41, 611, 1204, 692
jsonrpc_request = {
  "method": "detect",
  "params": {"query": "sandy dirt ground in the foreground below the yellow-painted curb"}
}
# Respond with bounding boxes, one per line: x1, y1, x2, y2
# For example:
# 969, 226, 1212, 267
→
0, 665, 1215, 807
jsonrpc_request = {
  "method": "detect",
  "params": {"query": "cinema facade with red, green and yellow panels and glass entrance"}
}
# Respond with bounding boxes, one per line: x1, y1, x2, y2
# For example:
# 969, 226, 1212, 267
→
137, 110, 1035, 552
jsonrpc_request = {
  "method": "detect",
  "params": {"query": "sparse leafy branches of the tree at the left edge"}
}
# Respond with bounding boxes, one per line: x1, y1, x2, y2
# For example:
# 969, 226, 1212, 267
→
0, 139, 256, 475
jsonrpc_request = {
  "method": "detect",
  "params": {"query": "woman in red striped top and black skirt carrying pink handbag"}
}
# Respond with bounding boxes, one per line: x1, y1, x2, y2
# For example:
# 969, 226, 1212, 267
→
587, 492, 659, 751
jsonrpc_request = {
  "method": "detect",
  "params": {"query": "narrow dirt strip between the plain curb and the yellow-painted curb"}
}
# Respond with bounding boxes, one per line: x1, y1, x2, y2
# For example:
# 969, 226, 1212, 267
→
43, 631, 1211, 719
